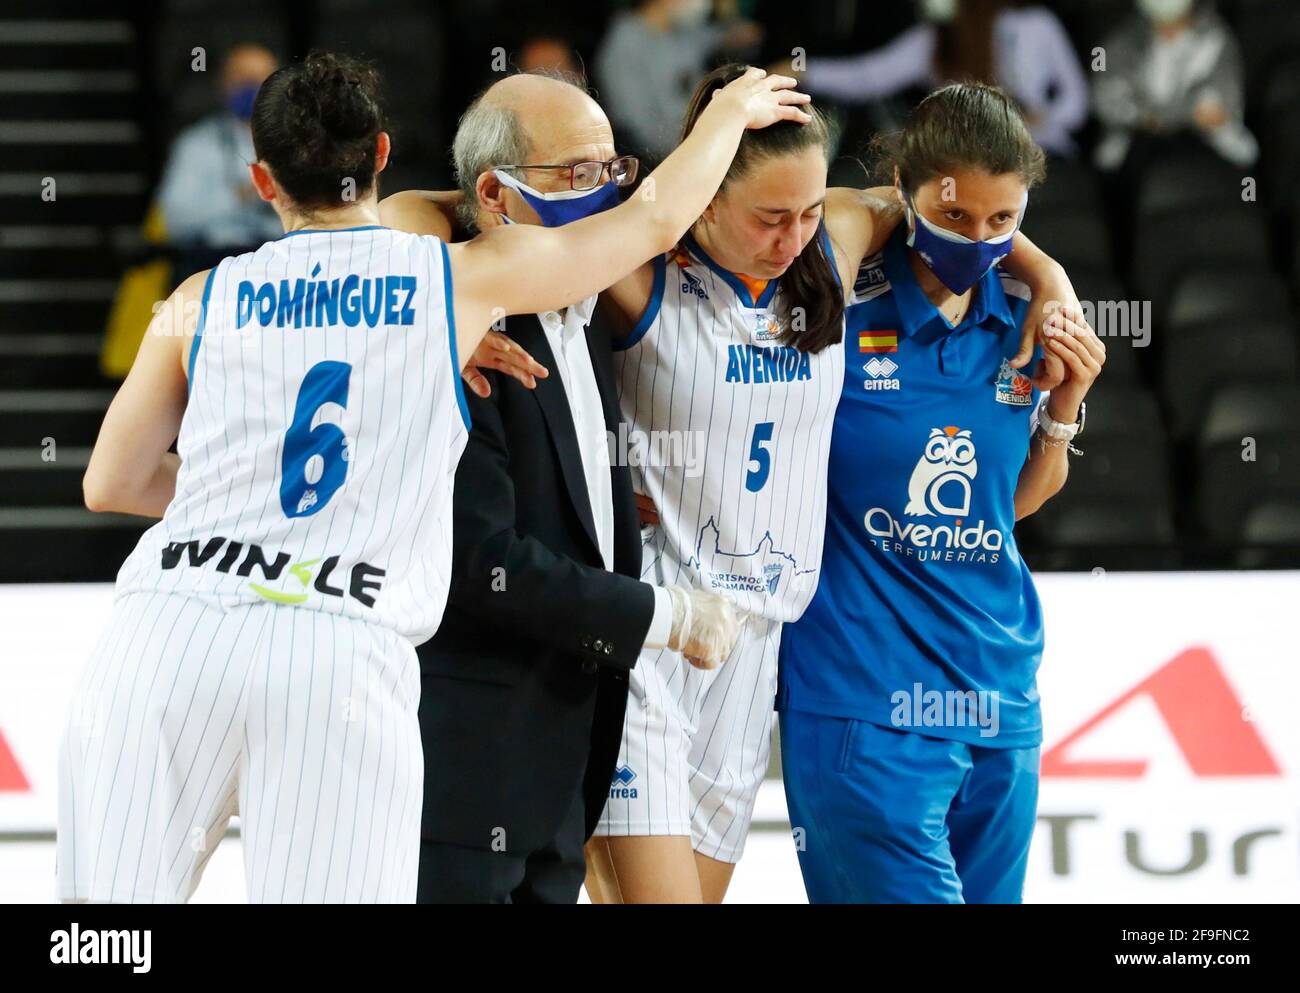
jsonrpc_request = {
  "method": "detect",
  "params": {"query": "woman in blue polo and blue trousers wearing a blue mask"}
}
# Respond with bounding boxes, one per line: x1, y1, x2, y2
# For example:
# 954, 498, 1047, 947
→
777, 84, 1105, 902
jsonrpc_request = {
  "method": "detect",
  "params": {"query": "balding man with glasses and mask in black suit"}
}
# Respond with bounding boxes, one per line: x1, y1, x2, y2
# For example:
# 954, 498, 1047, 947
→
382, 75, 735, 903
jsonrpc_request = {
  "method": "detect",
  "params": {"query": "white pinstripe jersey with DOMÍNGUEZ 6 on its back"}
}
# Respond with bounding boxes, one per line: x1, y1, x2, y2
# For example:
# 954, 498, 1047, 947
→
117, 226, 469, 643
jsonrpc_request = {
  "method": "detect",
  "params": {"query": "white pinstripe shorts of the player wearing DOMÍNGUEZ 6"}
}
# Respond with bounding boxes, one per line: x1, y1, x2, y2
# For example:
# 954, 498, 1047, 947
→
57, 593, 424, 903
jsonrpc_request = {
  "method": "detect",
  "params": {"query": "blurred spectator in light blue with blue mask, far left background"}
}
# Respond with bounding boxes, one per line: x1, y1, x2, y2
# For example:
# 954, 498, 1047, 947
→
159, 44, 283, 273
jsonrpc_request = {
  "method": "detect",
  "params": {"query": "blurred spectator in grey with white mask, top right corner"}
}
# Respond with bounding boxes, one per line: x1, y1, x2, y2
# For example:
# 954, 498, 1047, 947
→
1096, 0, 1258, 170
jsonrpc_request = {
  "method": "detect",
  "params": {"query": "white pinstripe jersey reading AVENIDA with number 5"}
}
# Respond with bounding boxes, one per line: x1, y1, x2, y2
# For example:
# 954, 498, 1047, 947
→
615, 233, 844, 621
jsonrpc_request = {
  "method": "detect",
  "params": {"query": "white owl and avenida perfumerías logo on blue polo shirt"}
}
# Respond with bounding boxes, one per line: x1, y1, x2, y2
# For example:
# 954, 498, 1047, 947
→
863, 425, 1005, 563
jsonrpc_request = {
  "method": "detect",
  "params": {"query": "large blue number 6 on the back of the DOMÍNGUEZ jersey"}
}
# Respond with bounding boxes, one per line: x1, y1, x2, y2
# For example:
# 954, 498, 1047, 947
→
280, 361, 352, 517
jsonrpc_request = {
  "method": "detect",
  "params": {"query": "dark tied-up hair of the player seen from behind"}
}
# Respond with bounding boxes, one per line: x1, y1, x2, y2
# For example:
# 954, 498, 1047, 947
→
252, 52, 384, 209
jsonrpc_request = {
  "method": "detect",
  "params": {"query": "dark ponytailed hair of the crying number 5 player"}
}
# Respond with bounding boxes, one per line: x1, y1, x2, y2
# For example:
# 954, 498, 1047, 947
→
681, 65, 844, 352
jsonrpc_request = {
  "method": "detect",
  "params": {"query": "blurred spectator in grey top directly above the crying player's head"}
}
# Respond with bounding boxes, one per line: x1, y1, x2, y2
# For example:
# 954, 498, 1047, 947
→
595, 0, 763, 161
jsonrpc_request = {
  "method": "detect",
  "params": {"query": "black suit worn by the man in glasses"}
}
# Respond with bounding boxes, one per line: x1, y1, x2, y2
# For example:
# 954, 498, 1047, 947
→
417, 300, 655, 902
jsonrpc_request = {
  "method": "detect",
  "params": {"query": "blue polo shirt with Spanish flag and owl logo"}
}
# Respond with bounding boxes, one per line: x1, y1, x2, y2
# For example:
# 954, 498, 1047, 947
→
777, 226, 1043, 747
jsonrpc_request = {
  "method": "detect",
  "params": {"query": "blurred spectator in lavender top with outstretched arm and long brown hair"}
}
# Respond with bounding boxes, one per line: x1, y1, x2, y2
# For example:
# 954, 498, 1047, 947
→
772, 0, 1088, 156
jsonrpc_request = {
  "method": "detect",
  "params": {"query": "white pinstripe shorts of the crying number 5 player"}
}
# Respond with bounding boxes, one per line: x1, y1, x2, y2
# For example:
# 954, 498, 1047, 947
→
595, 605, 781, 862
